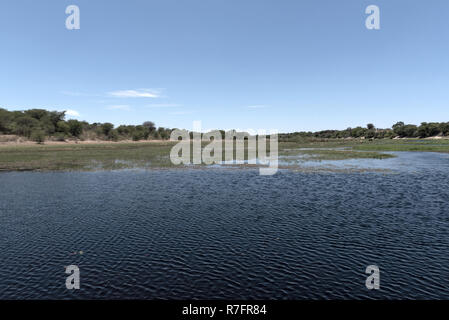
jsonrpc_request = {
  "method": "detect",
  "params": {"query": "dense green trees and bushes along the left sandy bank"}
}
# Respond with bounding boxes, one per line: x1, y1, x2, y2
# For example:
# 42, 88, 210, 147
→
0, 108, 172, 142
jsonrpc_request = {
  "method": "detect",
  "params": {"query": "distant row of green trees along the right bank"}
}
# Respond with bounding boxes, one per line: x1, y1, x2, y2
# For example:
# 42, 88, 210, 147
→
280, 122, 449, 141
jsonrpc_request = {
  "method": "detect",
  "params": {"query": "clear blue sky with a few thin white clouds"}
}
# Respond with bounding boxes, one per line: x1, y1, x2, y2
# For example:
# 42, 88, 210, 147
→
0, 0, 449, 132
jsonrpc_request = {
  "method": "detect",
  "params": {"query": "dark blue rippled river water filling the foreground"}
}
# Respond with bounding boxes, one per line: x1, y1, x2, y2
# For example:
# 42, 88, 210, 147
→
0, 153, 449, 299
